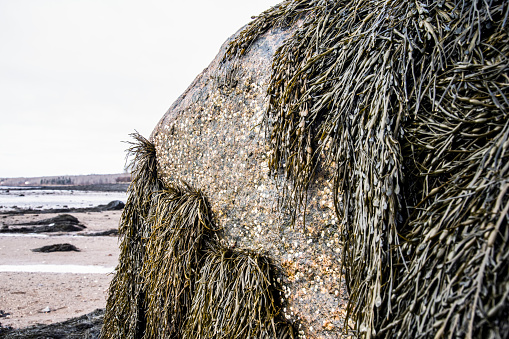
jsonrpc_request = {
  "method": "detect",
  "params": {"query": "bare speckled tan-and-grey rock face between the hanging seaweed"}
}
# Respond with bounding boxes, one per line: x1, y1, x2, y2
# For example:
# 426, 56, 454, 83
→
152, 22, 347, 338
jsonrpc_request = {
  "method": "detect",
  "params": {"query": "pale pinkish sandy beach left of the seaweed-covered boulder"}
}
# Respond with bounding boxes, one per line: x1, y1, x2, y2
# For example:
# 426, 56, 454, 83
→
0, 211, 122, 328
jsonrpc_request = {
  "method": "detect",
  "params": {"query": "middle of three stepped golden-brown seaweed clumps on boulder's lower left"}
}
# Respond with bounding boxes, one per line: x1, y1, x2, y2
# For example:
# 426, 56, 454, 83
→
143, 183, 218, 338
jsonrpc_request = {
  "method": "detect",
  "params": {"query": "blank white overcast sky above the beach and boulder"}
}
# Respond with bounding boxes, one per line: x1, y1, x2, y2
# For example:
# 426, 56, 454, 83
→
0, 0, 280, 177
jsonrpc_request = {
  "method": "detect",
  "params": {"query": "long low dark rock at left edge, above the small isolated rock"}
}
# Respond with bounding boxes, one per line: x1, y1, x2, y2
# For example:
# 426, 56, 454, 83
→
0, 214, 86, 233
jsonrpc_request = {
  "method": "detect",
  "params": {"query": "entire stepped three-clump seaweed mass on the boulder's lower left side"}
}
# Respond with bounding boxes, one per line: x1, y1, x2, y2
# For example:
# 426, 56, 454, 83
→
101, 134, 293, 339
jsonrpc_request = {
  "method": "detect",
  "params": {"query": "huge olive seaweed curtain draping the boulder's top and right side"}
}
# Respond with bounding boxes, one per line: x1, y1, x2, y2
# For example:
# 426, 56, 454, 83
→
225, 0, 509, 338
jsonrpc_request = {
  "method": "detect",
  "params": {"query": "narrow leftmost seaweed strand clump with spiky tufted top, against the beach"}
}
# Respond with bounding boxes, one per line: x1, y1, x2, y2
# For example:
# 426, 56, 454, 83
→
101, 133, 163, 339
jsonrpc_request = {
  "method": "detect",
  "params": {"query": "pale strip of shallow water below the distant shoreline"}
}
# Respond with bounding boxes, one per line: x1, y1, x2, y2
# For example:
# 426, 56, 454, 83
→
0, 187, 127, 212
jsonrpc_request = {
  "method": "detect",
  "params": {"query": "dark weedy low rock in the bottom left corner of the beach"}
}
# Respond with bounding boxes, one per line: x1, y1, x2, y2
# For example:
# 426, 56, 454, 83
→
0, 309, 104, 339
